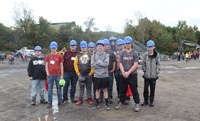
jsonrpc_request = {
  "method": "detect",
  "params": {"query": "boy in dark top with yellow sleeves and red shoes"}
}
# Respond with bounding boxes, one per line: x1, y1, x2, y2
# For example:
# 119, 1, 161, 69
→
74, 41, 94, 105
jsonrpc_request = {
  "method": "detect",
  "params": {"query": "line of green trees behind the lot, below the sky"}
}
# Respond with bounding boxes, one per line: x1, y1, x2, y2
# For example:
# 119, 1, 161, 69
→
0, 4, 200, 55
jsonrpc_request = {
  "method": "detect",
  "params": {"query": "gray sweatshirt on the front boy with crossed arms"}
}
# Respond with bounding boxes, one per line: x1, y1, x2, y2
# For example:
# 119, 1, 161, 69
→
91, 52, 109, 78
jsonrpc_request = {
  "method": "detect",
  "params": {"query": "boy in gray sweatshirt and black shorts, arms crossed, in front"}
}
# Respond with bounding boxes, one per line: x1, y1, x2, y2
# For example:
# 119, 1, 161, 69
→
91, 40, 110, 110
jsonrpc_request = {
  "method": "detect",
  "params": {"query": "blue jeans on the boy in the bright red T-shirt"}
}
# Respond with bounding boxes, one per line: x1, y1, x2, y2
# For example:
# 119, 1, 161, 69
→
48, 76, 62, 103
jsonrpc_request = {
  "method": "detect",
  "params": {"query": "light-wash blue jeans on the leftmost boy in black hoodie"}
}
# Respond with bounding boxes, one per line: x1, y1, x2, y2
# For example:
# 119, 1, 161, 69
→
31, 80, 45, 102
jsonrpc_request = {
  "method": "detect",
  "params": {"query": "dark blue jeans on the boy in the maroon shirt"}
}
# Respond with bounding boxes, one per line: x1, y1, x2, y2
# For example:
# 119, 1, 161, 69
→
63, 72, 78, 100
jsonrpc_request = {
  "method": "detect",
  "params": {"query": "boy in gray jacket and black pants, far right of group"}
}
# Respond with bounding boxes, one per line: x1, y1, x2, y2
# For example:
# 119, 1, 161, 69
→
142, 40, 160, 107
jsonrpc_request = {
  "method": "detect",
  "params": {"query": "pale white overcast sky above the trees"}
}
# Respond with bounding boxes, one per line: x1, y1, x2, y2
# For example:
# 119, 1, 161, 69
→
0, 0, 200, 32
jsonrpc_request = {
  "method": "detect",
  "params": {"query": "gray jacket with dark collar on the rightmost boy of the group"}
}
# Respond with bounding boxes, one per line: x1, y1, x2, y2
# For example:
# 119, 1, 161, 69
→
142, 51, 160, 79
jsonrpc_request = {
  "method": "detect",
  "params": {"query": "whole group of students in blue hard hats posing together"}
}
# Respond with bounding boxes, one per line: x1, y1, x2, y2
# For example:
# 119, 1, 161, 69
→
27, 36, 160, 112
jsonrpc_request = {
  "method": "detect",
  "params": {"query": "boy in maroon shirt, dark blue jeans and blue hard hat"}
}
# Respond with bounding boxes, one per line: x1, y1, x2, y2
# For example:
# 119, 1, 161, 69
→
62, 40, 79, 103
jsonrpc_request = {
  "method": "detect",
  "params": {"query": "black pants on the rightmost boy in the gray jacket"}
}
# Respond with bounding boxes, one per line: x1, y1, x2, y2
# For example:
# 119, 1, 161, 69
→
143, 79, 156, 103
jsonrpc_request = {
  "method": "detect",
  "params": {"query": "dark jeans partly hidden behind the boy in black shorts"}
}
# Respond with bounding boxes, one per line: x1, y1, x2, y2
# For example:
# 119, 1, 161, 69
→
100, 72, 114, 99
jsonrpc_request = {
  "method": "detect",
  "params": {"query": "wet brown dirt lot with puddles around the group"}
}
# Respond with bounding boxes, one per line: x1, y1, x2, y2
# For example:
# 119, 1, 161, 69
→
0, 60, 200, 121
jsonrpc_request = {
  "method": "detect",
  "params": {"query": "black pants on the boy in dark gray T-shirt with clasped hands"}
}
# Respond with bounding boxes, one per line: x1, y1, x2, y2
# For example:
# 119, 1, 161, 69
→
120, 74, 140, 104
